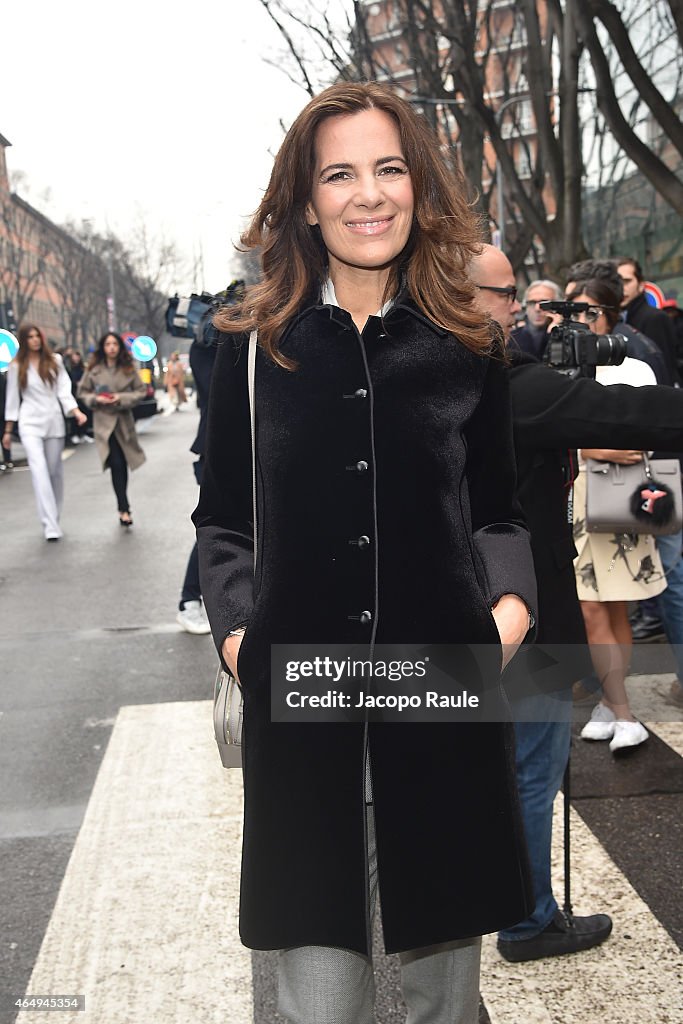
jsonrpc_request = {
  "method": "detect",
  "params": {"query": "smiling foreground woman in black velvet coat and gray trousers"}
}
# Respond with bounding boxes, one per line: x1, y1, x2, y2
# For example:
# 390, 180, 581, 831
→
194, 84, 536, 1024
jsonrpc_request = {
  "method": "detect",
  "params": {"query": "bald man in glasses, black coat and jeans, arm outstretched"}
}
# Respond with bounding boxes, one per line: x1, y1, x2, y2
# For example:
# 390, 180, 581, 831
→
470, 246, 683, 963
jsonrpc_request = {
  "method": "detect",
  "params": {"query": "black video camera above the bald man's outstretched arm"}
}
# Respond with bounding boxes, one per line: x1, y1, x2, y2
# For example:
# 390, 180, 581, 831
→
539, 300, 627, 378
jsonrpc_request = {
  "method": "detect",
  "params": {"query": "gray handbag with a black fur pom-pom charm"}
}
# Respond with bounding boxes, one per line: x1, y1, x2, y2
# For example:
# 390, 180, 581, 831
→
586, 453, 683, 537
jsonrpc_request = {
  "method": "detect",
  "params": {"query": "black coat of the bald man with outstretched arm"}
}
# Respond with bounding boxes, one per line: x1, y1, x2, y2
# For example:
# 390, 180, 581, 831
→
505, 353, 683, 696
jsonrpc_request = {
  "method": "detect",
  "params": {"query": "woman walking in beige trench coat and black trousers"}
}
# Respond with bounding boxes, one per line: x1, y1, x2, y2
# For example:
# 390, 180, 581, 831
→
78, 331, 145, 528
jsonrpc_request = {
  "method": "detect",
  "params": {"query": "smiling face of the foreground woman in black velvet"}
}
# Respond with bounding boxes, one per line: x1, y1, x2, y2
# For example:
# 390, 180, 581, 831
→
306, 110, 414, 283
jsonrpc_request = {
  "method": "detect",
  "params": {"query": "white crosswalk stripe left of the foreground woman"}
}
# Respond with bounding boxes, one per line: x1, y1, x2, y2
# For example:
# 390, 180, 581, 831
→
17, 701, 253, 1024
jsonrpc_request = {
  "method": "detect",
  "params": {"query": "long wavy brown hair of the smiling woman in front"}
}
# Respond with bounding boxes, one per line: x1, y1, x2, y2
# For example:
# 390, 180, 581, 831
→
219, 82, 492, 369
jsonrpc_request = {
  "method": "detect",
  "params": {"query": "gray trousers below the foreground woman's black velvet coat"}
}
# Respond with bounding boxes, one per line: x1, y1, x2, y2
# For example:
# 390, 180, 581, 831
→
278, 804, 481, 1024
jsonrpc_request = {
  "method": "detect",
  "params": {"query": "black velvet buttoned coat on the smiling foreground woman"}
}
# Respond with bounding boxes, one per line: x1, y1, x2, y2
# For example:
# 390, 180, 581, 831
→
194, 302, 536, 953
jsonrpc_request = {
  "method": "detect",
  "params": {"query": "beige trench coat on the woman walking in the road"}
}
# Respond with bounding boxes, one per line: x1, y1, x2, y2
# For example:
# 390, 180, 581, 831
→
78, 362, 146, 469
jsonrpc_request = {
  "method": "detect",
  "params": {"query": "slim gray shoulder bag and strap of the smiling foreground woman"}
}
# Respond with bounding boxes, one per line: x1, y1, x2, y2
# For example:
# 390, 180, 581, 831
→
213, 331, 257, 768
